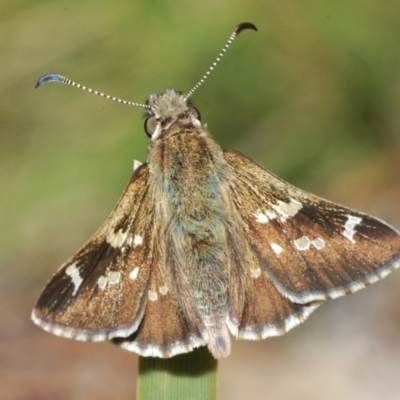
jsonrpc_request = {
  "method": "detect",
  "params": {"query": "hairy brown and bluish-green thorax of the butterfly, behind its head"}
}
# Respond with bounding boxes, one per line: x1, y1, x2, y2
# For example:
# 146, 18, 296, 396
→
148, 126, 227, 242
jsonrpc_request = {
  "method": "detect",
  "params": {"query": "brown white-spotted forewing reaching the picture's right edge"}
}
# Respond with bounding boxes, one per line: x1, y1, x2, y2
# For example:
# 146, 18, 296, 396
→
224, 151, 400, 304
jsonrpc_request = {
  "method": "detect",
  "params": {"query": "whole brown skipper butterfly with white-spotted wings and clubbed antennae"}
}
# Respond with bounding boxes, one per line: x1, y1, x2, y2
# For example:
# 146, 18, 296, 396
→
32, 23, 400, 358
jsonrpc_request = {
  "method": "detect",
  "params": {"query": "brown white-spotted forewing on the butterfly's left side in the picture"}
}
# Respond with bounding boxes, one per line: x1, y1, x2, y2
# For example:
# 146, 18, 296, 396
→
33, 165, 157, 340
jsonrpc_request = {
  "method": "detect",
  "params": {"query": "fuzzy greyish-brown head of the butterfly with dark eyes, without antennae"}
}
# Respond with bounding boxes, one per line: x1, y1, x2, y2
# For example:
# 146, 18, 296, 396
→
144, 89, 201, 140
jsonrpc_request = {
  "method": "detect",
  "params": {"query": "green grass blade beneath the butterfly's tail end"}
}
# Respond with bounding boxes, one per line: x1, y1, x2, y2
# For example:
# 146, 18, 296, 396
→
137, 347, 218, 400
